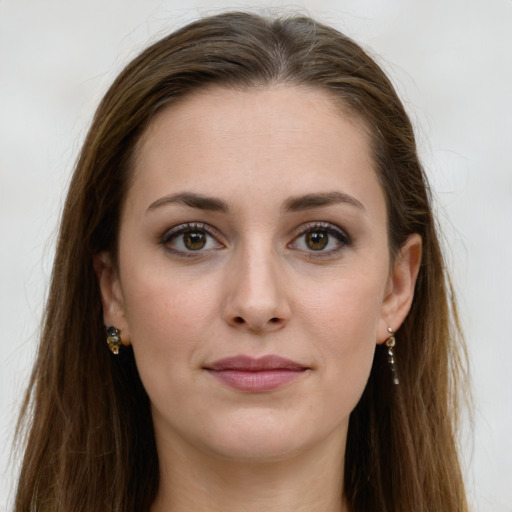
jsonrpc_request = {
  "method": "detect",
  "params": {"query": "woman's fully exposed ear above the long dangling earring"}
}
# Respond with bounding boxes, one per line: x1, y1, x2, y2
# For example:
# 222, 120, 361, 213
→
377, 233, 422, 344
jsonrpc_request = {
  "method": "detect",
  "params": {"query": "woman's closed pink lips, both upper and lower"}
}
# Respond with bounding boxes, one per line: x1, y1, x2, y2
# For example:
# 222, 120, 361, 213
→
204, 355, 308, 393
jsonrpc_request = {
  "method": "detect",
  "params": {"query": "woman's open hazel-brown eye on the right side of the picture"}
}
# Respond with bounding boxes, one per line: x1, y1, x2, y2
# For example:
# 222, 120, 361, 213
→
290, 222, 352, 254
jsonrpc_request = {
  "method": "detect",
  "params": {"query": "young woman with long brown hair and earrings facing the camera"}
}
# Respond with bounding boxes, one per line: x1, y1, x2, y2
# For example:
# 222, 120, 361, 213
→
16, 13, 467, 512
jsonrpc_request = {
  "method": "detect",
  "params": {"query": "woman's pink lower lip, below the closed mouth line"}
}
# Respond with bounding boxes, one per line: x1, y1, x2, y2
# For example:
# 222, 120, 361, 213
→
208, 369, 305, 393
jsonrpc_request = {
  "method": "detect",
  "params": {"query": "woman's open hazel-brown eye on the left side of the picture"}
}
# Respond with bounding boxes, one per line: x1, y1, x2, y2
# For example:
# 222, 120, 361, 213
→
161, 223, 223, 254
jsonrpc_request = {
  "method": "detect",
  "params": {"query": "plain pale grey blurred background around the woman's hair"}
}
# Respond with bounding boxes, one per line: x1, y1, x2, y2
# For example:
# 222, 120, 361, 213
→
0, 0, 512, 512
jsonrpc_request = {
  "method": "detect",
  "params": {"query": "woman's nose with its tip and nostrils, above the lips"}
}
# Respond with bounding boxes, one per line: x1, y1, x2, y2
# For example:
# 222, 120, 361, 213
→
223, 243, 291, 334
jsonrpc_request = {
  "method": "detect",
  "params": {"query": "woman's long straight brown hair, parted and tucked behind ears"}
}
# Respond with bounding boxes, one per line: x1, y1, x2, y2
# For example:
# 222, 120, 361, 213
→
15, 13, 467, 512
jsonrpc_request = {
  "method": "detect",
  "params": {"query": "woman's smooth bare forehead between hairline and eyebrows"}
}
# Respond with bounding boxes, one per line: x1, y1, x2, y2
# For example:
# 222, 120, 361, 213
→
128, 85, 382, 218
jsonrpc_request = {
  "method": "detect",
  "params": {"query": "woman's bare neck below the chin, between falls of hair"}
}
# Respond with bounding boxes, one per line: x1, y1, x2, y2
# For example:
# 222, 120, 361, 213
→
151, 430, 348, 512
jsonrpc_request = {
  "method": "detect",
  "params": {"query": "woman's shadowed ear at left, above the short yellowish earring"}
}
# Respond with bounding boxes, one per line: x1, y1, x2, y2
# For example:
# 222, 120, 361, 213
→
93, 251, 130, 345
